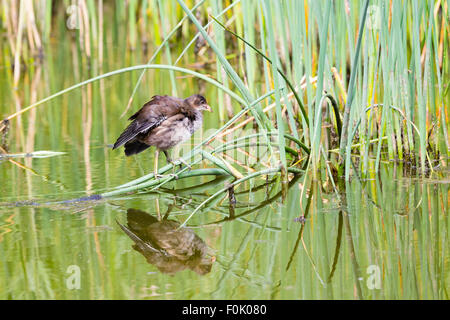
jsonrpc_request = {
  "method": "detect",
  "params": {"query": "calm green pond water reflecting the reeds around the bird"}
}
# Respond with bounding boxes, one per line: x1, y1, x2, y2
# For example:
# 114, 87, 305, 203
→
0, 40, 450, 299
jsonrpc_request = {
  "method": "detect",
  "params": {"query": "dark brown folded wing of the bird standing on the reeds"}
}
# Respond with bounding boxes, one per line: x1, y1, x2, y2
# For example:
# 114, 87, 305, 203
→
113, 96, 182, 149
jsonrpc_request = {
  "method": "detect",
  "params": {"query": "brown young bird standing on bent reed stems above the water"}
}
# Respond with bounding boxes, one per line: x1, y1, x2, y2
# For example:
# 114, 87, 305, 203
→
113, 94, 212, 178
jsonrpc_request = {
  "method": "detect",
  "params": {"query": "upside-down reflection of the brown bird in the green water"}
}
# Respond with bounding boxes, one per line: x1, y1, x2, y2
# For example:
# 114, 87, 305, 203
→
117, 208, 215, 275
